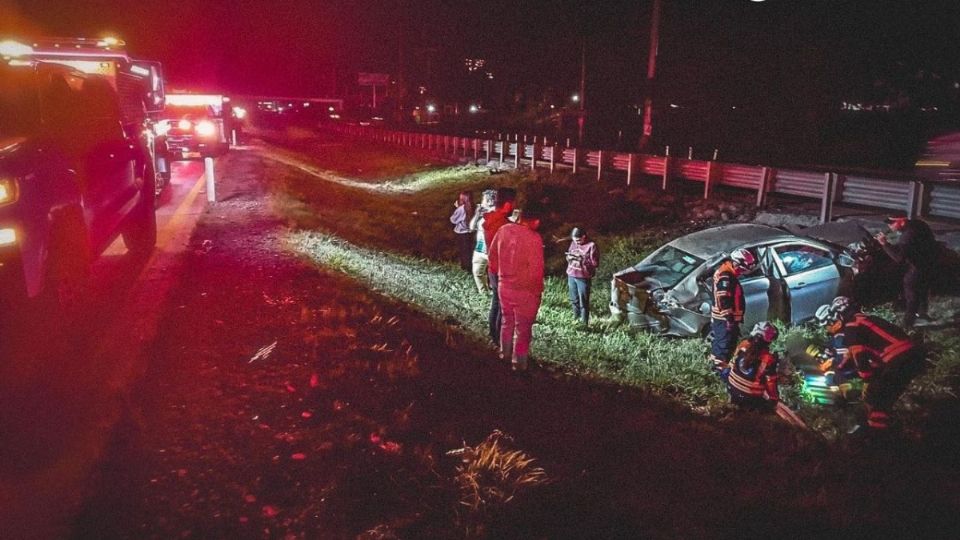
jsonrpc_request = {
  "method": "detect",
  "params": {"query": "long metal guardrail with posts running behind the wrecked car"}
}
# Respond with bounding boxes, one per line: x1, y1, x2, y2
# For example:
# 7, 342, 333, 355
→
335, 125, 960, 221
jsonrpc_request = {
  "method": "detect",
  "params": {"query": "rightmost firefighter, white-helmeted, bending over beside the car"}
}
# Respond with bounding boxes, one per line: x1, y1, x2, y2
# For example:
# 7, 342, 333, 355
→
818, 296, 924, 432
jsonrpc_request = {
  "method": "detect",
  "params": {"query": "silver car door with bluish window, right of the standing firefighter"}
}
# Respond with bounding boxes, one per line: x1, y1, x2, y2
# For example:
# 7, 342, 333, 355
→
773, 242, 840, 324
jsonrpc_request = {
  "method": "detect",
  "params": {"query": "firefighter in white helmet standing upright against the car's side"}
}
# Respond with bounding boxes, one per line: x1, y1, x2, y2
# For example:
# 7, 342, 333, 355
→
710, 249, 757, 373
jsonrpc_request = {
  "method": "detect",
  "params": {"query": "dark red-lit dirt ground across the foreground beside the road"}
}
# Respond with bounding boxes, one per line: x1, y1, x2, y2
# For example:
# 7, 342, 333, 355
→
72, 137, 960, 538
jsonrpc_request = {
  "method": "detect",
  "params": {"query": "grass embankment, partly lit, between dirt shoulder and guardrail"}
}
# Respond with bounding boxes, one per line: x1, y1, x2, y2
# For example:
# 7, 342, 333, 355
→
260, 141, 960, 436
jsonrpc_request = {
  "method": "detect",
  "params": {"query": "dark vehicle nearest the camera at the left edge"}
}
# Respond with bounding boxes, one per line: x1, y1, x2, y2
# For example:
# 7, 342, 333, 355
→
0, 61, 157, 330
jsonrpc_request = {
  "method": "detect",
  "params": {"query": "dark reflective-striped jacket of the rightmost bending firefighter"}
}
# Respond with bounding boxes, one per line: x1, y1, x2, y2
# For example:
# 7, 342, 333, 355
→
843, 313, 914, 380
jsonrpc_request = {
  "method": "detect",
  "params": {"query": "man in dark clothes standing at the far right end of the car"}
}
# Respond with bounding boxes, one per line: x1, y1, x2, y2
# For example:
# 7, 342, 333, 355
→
877, 216, 939, 329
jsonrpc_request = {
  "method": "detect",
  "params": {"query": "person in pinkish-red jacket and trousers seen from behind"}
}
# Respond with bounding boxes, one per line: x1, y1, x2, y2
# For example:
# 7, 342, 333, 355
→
487, 204, 543, 371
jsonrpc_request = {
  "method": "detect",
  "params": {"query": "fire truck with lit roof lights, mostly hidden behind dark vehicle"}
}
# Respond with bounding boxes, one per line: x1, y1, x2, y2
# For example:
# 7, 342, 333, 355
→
8, 37, 170, 195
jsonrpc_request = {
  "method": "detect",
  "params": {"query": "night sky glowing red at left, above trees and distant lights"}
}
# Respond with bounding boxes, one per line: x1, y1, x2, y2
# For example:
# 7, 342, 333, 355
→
0, 0, 960, 146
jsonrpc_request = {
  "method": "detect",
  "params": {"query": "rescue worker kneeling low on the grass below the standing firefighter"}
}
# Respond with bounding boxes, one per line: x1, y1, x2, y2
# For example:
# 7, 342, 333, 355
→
720, 322, 780, 412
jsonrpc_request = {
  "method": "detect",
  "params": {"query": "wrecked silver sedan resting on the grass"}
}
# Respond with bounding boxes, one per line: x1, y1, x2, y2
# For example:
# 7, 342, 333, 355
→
610, 224, 869, 336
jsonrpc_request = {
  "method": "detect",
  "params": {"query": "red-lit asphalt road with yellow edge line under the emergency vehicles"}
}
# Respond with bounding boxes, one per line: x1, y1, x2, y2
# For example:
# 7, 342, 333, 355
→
0, 162, 214, 538
